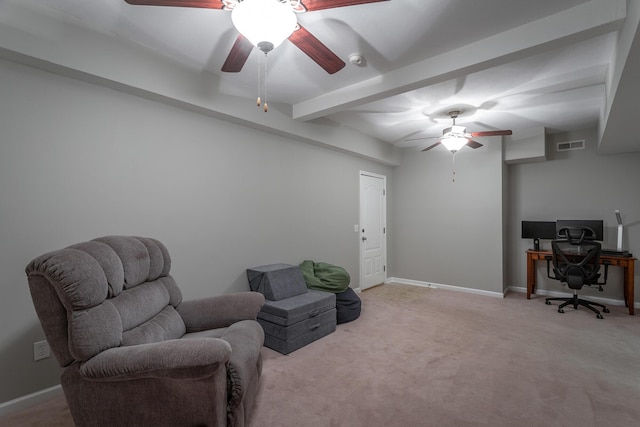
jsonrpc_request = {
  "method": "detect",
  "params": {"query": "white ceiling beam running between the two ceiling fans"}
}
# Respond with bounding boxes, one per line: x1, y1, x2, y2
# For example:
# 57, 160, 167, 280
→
293, 0, 626, 121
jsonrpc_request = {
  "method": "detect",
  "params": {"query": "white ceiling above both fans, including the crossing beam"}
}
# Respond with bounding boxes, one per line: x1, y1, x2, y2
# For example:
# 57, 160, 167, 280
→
0, 0, 640, 156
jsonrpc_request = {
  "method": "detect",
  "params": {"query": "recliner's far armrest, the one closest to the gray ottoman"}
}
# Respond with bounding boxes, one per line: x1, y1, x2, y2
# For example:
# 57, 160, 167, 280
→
176, 292, 264, 332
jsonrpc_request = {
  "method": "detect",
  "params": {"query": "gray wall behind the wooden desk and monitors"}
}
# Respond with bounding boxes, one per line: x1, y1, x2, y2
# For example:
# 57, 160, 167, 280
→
508, 129, 640, 300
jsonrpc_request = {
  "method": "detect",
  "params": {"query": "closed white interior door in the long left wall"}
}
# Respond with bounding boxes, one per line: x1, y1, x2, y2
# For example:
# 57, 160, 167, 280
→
360, 172, 387, 290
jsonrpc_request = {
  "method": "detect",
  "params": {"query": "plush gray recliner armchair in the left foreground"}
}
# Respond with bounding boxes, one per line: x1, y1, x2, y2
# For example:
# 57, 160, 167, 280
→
26, 236, 264, 426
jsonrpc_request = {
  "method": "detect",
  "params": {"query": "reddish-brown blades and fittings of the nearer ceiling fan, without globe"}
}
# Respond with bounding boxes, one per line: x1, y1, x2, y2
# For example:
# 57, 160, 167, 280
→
125, 0, 389, 74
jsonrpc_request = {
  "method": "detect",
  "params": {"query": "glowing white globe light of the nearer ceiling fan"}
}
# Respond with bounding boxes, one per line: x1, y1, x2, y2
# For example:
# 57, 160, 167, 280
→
231, 0, 298, 53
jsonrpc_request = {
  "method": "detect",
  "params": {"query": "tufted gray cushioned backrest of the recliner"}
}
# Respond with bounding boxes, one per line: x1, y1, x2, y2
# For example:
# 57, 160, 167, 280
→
26, 236, 185, 366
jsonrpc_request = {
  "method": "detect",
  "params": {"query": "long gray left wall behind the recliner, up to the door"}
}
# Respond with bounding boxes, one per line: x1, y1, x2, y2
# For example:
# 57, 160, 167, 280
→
0, 60, 392, 402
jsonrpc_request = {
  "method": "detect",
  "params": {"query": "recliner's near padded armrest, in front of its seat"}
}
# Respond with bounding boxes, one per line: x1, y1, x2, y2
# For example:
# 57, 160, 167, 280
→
80, 338, 231, 381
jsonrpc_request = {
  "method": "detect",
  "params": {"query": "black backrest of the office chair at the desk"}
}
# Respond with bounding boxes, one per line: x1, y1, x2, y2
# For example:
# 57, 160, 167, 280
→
551, 228, 602, 289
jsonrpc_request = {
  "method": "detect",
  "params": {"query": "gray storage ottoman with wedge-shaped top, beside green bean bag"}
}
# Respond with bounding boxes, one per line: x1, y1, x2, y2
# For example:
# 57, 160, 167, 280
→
247, 264, 336, 354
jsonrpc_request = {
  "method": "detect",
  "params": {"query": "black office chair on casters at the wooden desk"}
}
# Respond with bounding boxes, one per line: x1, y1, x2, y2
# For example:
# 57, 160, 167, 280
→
545, 227, 609, 319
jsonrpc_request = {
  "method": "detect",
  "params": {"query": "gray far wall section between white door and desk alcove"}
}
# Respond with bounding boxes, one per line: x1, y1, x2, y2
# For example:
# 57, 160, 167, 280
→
389, 137, 504, 293
